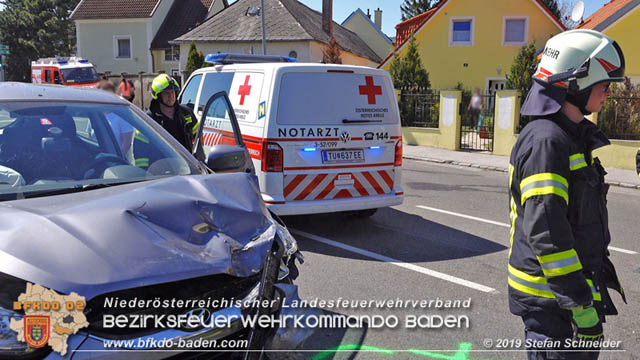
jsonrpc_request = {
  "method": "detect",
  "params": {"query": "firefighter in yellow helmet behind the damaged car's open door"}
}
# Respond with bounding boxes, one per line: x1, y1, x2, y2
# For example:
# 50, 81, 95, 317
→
134, 74, 205, 168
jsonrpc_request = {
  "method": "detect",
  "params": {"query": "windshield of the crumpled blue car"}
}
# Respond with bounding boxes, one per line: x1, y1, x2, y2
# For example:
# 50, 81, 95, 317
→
0, 101, 201, 200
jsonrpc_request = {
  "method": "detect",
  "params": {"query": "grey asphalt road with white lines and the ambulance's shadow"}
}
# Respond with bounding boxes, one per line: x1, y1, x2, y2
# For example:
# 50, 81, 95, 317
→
285, 160, 640, 360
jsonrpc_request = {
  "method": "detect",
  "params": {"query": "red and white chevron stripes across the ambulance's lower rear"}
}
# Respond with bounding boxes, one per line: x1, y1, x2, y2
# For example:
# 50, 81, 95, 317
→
284, 169, 394, 201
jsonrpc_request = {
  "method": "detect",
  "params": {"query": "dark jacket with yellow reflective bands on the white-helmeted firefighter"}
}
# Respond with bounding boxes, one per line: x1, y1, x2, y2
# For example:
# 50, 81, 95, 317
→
507, 113, 626, 316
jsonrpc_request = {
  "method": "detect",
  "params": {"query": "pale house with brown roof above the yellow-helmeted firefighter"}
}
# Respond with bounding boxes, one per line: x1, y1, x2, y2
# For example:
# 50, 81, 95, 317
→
71, 0, 229, 74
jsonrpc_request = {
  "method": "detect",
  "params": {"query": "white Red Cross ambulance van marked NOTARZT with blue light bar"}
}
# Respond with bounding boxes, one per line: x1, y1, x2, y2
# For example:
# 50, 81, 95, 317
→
179, 54, 404, 216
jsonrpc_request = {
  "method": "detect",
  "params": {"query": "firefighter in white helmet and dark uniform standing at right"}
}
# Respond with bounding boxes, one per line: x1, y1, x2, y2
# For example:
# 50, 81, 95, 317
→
508, 30, 626, 359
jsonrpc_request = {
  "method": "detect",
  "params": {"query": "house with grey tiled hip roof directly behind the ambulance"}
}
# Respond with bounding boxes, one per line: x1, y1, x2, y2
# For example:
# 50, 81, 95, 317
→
172, 0, 382, 69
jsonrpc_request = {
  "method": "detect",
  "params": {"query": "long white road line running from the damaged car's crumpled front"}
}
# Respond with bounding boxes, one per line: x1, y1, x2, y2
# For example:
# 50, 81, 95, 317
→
290, 229, 498, 294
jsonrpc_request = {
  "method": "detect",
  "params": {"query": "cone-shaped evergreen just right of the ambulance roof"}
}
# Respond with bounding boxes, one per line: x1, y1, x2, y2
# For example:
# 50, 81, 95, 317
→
389, 36, 431, 92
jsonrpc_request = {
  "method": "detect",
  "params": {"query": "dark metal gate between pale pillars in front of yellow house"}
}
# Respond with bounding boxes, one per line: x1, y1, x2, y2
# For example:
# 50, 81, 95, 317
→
460, 91, 496, 151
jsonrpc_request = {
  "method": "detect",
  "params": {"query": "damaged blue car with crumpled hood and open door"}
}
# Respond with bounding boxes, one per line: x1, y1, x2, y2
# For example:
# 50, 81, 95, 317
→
0, 83, 302, 359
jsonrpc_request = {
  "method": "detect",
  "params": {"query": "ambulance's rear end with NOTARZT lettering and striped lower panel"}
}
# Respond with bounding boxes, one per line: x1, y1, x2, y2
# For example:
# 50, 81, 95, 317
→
268, 66, 402, 204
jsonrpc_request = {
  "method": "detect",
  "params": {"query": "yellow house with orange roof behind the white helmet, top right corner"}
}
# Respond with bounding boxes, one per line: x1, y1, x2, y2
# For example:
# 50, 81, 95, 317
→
576, 0, 640, 84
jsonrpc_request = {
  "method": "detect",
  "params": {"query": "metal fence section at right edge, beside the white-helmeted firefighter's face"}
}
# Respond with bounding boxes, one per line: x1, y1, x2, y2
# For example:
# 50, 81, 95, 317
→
598, 96, 640, 140
